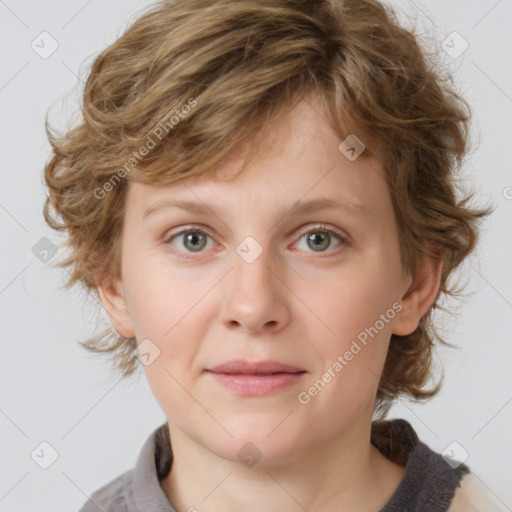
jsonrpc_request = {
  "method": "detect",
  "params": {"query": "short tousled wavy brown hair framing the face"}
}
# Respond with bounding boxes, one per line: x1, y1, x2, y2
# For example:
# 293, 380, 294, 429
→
44, 0, 491, 415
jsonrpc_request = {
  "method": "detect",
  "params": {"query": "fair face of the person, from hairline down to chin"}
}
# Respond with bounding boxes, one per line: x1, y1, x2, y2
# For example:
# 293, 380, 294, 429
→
101, 98, 433, 463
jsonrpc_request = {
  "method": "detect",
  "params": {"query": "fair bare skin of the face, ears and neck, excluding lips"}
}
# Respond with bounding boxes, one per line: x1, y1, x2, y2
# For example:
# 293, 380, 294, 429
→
99, 97, 441, 512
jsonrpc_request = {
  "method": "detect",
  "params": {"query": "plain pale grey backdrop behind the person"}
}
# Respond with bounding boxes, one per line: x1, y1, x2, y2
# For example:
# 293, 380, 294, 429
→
0, 0, 512, 512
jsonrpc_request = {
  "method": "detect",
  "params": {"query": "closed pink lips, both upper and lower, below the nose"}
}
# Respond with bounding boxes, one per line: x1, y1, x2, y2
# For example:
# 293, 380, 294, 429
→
207, 359, 306, 396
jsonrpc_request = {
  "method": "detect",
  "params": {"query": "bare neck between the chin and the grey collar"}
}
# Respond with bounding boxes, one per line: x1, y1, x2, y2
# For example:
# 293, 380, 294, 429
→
161, 422, 404, 512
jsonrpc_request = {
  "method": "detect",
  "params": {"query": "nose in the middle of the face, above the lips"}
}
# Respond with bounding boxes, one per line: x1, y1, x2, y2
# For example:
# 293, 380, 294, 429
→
221, 241, 290, 334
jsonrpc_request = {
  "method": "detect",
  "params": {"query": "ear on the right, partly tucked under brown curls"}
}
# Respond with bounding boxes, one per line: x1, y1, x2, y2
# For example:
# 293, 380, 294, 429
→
392, 250, 444, 336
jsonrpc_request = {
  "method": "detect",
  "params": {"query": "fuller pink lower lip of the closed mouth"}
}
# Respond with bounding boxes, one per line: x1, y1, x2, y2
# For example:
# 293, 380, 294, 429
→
210, 372, 306, 396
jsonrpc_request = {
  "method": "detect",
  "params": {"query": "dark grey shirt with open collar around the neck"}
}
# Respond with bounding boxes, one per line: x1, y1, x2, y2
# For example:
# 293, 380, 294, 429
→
79, 419, 469, 512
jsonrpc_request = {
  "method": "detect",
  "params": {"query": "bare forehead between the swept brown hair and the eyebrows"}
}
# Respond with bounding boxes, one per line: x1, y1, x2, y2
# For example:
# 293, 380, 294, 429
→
125, 97, 387, 223
